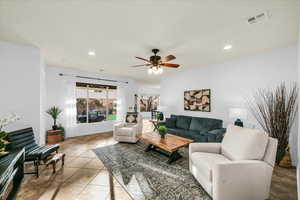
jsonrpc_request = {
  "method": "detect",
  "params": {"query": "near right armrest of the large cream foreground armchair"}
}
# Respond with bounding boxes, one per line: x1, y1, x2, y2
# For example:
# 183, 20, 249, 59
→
213, 160, 273, 200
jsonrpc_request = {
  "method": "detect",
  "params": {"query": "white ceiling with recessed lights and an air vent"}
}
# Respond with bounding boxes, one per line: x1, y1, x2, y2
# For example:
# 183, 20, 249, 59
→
0, 0, 300, 83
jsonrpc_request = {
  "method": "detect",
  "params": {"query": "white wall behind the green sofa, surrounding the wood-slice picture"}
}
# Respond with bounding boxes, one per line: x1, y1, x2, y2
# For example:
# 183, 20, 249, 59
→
160, 45, 297, 164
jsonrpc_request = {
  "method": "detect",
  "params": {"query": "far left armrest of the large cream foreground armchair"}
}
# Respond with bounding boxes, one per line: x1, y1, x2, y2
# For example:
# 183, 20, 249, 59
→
189, 143, 221, 154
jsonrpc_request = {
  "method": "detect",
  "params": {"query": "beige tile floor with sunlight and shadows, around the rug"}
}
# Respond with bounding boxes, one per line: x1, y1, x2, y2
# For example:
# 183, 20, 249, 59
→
17, 122, 297, 200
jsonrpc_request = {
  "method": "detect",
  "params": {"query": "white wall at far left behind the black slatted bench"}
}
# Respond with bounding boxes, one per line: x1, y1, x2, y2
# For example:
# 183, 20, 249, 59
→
0, 41, 45, 142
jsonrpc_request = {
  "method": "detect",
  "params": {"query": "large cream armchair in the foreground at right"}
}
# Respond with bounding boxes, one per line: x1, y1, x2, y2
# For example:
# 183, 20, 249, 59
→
189, 125, 277, 200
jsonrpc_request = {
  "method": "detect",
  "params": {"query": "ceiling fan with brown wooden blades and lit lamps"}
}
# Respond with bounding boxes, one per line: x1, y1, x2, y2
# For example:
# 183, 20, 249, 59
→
131, 49, 180, 74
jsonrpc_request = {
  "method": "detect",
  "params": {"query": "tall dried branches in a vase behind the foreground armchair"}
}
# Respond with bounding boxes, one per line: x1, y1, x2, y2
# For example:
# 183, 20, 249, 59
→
249, 83, 298, 165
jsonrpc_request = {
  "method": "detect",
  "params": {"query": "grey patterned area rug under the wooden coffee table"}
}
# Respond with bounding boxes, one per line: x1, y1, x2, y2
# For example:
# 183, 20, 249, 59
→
94, 142, 211, 200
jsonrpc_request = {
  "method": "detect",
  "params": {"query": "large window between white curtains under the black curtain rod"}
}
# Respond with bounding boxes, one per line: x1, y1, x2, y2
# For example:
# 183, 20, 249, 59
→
76, 83, 117, 123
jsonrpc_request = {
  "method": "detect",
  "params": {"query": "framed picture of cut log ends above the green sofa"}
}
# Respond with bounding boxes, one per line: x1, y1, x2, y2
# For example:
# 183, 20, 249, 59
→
184, 89, 211, 112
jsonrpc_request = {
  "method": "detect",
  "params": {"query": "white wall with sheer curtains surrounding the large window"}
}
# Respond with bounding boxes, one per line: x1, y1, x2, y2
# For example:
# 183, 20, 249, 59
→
46, 67, 137, 137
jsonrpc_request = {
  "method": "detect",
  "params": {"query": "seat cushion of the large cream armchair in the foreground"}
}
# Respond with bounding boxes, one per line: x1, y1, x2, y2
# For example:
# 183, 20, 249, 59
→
190, 152, 230, 182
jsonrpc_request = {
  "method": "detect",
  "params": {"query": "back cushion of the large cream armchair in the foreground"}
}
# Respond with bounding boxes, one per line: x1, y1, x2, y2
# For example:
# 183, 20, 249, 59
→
222, 125, 269, 160
